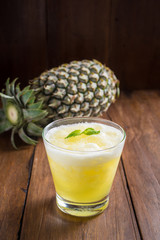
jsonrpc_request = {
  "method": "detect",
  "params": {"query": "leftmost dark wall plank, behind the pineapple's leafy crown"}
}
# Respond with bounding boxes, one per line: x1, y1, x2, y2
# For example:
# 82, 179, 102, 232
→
0, 0, 47, 88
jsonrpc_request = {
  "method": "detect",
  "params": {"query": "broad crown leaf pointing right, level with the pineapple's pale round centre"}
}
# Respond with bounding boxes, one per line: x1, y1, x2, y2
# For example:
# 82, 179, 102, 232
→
23, 109, 48, 121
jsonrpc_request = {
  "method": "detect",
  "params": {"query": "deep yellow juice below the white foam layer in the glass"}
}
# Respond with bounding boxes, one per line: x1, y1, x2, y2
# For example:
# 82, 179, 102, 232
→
48, 156, 119, 203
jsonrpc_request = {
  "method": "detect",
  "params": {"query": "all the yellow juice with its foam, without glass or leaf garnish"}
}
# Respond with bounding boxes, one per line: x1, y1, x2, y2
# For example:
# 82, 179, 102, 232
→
46, 123, 123, 203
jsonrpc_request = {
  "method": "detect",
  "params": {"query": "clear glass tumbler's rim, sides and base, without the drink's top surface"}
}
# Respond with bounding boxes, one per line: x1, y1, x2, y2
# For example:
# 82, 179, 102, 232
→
42, 117, 126, 216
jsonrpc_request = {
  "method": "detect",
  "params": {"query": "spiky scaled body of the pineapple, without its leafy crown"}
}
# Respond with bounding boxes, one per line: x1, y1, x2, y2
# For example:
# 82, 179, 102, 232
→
30, 60, 119, 123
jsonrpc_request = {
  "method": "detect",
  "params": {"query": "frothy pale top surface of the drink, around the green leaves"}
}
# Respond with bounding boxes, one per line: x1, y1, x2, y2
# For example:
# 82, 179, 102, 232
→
46, 123, 123, 151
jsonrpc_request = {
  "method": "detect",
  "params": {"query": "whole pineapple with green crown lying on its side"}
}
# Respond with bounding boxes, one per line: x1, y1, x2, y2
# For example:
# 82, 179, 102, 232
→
0, 60, 119, 148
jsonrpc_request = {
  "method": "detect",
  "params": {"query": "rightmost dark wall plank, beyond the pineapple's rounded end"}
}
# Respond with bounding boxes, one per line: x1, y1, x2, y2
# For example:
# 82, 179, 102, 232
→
108, 0, 160, 91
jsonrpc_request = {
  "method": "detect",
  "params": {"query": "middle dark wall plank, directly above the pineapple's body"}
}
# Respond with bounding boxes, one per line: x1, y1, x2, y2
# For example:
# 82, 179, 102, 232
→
47, 0, 111, 67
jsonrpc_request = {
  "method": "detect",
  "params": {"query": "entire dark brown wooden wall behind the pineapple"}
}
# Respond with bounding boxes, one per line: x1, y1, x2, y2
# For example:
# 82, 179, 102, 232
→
0, 0, 160, 90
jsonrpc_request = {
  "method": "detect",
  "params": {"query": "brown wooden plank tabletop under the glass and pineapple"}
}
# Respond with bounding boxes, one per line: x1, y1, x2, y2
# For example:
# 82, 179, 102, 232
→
0, 91, 160, 240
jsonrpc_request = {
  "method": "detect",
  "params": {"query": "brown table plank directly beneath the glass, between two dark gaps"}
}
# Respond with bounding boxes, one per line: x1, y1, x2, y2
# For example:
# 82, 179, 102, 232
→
20, 137, 140, 240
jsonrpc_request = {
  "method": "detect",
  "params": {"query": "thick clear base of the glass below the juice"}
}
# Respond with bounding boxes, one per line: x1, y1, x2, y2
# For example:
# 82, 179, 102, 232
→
56, 194, 109, 217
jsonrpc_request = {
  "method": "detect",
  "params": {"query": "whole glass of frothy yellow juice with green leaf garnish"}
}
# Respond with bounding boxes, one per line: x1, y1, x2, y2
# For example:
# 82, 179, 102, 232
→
42, 117, 126, 216
